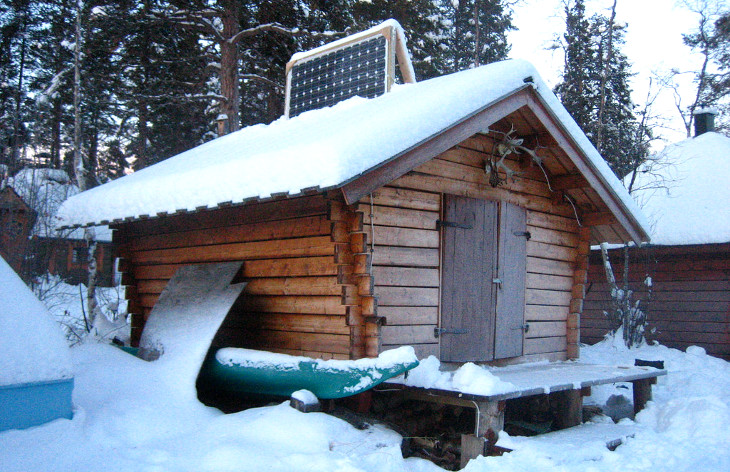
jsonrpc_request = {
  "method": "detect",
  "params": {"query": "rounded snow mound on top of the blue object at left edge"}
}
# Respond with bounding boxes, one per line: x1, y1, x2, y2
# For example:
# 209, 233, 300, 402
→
0, 257, 72, 387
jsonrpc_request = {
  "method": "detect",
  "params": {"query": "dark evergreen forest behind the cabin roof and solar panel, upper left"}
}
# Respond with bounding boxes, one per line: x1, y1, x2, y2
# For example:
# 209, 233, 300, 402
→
0, 0, 512, 181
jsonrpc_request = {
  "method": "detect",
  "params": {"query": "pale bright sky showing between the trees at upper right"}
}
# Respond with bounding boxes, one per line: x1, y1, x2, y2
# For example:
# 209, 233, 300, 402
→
510, 0, 722, 150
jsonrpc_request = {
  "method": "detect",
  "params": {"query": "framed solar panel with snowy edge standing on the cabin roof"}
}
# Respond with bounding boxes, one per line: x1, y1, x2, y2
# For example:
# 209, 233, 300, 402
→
286, 20, 416, 118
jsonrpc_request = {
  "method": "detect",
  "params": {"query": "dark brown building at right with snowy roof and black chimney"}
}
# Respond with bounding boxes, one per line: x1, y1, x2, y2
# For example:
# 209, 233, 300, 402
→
583, 116, 730, 359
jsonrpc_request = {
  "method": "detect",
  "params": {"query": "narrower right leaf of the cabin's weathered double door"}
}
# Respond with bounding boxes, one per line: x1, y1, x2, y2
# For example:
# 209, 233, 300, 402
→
494, 202, 529, 359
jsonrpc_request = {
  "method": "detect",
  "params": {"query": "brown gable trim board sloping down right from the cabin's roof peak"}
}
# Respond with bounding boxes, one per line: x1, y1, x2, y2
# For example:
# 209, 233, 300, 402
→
527, 93, 649, 244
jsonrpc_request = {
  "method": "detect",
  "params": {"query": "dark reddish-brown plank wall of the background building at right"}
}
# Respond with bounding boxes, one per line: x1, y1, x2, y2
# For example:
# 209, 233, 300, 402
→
582, 244, 730, 360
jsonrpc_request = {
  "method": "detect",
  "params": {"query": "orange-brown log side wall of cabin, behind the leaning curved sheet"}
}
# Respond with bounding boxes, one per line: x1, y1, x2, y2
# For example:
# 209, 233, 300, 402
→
116, 195, 363, 359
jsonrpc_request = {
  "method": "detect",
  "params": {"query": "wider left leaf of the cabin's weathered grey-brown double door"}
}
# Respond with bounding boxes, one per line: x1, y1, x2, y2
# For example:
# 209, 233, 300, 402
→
439, 195, 499, 362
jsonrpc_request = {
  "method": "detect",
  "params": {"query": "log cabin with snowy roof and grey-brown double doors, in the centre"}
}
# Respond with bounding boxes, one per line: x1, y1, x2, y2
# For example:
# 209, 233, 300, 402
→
58, 60, 648, 363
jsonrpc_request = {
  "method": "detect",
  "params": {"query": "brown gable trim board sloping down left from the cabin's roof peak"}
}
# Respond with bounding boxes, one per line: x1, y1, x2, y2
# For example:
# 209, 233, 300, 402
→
341, 85, 532, 205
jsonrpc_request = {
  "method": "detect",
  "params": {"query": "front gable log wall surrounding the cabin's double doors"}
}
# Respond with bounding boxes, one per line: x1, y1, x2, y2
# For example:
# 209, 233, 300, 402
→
358, 135, 585, 360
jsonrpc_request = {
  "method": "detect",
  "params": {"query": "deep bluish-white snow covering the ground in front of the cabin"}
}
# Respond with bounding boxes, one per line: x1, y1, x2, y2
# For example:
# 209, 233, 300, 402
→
0, 332, 730, 472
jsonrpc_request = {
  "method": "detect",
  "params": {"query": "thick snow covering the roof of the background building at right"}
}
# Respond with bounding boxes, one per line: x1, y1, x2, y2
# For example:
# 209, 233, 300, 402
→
633, 132, 730, 245
